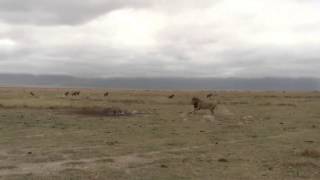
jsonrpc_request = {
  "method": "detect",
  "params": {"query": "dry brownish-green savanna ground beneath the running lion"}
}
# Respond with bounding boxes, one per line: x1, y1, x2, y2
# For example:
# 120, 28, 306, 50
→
0, 88, 320, 180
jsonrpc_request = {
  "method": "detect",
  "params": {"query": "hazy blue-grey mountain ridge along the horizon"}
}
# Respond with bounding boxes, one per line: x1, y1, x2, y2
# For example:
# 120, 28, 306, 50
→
0, 73, 320, 91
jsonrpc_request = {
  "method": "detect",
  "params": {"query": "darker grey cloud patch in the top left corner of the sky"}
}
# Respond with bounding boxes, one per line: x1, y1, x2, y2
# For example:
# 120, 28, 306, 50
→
0, 0, 148, 25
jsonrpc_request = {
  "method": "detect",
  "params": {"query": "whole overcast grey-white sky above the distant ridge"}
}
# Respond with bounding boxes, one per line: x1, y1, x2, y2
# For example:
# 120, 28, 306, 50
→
0, 0, 320, 77
